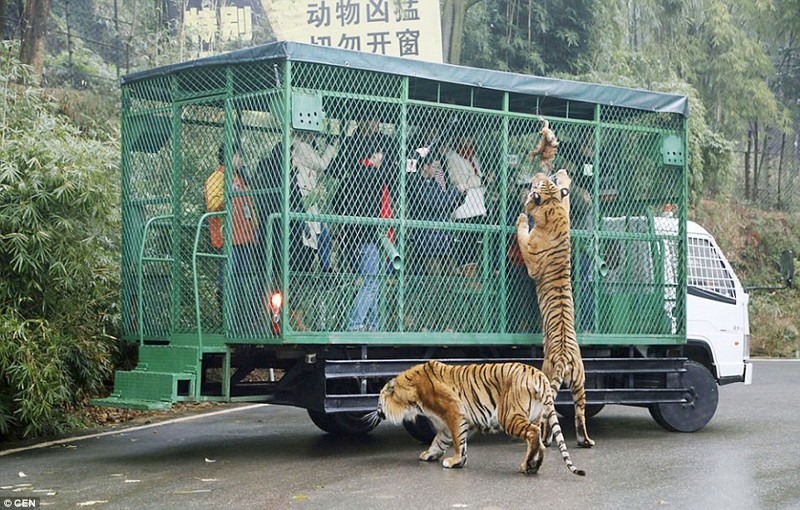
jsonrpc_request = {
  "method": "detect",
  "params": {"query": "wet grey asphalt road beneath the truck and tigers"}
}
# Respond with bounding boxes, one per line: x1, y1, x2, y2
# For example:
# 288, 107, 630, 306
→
0, 361, 800, 510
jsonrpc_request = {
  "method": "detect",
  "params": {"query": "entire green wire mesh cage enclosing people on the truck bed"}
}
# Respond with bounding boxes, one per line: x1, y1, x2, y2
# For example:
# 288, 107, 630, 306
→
123, 55, 685, 343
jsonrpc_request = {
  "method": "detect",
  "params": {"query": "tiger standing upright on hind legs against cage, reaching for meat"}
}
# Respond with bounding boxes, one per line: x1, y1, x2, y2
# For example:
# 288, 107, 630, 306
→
517, 121, 594, 448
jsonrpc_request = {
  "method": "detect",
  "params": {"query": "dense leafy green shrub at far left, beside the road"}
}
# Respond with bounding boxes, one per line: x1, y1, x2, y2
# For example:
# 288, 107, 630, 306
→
0, 43, 119, 436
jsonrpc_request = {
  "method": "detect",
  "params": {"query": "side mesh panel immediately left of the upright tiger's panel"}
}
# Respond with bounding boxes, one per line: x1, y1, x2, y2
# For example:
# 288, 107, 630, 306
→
404, 107, 507, 332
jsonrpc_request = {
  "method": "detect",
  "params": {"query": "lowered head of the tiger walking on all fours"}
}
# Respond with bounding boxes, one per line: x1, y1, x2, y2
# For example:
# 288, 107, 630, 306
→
376, 361, 438, 425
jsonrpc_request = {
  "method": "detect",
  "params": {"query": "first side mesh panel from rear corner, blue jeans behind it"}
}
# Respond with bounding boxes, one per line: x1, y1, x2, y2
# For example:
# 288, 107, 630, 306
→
304, 97, 402, 331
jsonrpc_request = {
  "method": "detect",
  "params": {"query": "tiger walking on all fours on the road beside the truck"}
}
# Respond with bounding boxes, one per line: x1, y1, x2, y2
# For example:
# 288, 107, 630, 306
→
377, 361, 585, 475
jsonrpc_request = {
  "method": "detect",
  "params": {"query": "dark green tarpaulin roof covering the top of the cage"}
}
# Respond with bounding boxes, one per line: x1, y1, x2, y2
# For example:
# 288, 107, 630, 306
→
122, 41, 689, 116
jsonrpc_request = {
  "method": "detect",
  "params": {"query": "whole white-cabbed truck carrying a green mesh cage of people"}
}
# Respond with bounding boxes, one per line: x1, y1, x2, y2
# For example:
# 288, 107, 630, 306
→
94, 42, 764, 436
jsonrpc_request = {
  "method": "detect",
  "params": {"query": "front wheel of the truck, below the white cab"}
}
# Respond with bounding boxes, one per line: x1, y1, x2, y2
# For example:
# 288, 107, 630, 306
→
650, 361, 719, 432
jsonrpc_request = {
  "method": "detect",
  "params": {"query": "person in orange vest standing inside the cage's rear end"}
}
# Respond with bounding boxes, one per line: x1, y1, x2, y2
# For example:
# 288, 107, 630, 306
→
203, 145, 259, 334
